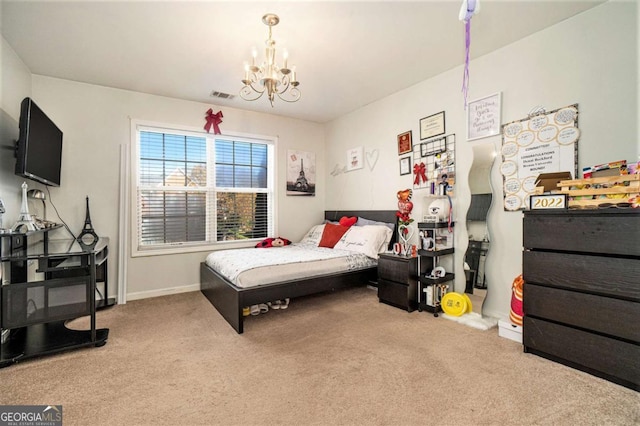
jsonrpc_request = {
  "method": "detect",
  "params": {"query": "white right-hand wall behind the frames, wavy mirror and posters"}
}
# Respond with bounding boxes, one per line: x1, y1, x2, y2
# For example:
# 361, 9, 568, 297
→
326, 1, 639, 317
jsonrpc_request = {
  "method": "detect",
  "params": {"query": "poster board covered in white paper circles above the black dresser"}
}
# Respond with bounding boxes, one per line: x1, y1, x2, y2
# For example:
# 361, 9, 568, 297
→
500, 104, 580, 211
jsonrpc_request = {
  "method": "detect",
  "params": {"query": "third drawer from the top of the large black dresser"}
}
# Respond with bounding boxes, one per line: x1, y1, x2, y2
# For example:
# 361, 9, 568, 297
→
522, 282, 640, 342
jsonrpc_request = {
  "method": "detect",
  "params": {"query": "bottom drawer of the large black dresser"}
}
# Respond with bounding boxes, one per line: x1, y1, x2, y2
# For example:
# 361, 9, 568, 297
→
522, 316, 640, 390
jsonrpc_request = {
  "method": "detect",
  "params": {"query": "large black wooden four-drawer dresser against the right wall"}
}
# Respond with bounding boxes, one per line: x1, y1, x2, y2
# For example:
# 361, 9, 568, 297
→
522, 208, 640, 390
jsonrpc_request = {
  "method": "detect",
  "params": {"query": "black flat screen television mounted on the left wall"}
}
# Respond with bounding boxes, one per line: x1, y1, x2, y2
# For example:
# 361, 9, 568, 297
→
16, 98, 62, 186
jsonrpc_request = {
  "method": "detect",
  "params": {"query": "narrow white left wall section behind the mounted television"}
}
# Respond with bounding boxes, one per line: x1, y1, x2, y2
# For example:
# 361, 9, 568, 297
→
0, 37, 32, 228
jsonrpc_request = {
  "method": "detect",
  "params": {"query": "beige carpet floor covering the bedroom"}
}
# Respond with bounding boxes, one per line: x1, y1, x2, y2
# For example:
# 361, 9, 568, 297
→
0, 287, 640, 425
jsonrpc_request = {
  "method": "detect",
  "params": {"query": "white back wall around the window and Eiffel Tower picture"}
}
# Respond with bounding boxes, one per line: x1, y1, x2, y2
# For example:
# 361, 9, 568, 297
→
25, 75, 325, 299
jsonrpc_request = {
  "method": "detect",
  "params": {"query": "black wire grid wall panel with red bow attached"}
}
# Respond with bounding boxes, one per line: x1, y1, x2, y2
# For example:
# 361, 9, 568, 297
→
412, 134, 456, 196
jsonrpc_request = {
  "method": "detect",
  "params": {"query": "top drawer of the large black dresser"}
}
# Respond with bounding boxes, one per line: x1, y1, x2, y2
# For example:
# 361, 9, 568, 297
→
523, 209, 640, 256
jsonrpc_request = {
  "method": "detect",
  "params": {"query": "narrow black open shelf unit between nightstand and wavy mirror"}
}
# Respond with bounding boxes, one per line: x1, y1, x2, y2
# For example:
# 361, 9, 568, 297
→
418, 222, 455, 317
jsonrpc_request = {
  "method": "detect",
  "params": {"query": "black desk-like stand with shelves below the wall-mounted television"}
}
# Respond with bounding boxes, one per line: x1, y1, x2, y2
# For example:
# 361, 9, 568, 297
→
0, 229, 109, 367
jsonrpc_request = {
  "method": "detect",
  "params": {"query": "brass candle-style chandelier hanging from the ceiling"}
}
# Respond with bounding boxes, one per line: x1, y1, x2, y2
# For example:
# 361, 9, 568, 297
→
240, 13, 300, 107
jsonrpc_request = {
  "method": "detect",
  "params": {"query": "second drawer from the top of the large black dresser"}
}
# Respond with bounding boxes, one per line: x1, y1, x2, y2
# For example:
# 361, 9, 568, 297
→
522, 251, 640, 302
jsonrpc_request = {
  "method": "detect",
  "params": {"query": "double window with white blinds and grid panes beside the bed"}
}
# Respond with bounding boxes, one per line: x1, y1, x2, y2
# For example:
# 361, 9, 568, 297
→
132, 125, 275, 254
